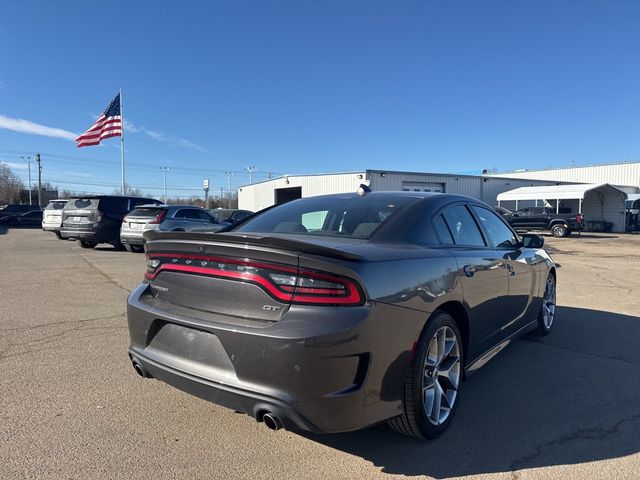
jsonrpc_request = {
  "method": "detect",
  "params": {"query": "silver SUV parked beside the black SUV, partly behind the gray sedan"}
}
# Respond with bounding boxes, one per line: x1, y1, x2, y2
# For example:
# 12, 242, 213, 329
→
120, 205, 229, 252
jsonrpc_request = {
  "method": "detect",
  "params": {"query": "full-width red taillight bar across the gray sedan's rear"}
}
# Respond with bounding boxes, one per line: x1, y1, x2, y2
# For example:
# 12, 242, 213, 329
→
145, 253, 364, 305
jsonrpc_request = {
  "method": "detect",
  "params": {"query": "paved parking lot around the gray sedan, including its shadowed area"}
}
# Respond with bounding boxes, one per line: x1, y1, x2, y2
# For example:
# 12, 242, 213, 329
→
0, 229, 640, 479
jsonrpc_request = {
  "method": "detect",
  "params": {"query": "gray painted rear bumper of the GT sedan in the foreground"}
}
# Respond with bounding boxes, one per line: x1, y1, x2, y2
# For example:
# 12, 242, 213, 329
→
128, 283, 425, 432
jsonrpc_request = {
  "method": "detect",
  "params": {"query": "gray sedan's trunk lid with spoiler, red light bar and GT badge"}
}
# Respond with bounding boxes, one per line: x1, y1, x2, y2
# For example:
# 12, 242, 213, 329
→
145, 231, 363, 321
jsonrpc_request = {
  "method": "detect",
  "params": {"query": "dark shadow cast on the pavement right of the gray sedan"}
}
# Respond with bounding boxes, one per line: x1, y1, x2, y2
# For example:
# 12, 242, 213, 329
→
303, 307, 640, 478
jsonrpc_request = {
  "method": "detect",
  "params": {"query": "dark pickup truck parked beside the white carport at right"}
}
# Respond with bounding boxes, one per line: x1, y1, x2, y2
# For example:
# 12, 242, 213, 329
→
496, 207, 585, 237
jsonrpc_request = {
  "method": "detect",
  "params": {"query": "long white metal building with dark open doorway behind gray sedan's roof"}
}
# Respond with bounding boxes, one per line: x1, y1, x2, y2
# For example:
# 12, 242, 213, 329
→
238, 170, 563, 212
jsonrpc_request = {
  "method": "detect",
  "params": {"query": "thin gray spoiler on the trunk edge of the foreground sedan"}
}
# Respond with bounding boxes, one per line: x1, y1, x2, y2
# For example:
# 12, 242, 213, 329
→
144, 230, 363, 261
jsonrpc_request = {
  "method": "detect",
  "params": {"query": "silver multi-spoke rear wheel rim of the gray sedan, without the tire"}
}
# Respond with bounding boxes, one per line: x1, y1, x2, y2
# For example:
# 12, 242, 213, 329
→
422, 326, 461, 425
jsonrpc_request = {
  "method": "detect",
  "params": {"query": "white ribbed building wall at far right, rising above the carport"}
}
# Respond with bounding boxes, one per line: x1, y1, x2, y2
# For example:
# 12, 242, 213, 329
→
492, 162, 640, 193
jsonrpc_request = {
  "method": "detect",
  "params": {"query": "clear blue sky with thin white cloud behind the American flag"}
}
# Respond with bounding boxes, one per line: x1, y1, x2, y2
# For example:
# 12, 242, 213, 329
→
0, 0, 640, 196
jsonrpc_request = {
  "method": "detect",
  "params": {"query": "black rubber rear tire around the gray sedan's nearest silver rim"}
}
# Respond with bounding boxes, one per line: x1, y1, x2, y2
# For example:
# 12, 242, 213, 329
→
388, 311, 464, 439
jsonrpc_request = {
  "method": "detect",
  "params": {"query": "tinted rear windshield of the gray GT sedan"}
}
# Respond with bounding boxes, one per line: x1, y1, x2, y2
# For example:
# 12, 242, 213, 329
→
233, 195, 419, 238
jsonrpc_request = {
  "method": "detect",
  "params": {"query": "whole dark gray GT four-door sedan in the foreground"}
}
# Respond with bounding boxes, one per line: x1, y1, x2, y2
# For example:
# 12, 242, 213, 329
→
128, 192, 556, 438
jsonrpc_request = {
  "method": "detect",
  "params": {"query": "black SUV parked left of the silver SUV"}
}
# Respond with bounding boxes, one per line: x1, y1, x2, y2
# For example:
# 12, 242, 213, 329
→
60, 195, 161, 249
